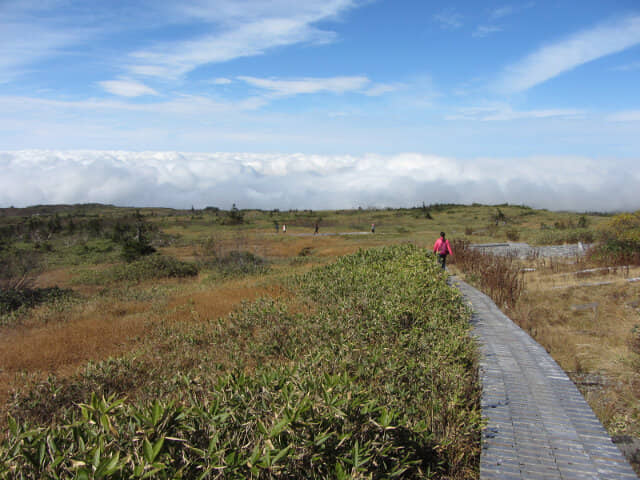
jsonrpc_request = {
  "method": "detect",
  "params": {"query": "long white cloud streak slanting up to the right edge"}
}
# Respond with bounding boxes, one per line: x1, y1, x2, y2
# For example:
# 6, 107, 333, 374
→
497, 15, 640, 93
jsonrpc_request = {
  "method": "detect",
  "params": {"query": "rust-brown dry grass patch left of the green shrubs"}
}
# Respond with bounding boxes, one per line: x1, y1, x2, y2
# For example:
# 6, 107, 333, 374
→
0, 279, 282, 404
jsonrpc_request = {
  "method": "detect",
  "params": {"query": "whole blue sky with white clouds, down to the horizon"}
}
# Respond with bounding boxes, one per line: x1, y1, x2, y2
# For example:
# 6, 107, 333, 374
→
0, 0, 640, 209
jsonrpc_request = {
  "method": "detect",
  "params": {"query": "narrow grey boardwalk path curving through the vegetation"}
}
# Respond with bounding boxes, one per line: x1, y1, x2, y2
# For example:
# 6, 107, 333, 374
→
451, 277, 638, 480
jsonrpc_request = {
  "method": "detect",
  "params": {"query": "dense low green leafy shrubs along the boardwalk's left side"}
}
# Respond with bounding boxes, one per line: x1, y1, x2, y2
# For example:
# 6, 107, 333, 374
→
0, 245, 480, 479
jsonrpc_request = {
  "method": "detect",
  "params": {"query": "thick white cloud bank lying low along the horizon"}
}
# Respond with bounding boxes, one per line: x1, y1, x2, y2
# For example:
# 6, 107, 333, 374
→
0, 150, 640, 211
